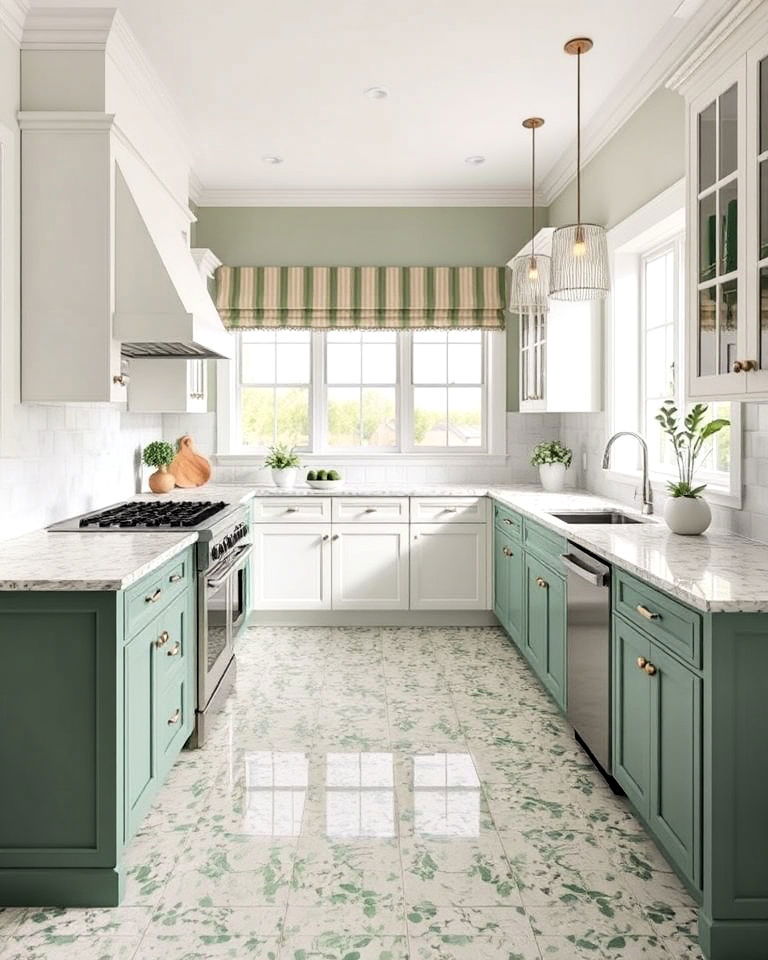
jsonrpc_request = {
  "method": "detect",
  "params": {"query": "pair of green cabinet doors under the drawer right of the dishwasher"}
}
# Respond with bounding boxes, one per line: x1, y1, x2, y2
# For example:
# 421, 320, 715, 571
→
613, 616, 703, 890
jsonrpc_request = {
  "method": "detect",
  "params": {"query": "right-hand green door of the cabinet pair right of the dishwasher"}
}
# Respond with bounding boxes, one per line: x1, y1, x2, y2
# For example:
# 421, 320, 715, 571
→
638, 644, 702, 888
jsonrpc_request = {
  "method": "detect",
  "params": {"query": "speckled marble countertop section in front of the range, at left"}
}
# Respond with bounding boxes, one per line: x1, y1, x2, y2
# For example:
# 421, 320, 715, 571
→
0, 530, 197, 591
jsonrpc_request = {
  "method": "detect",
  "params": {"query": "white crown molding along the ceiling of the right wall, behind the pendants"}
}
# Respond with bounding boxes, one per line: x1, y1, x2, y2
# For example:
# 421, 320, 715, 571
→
541, 0, 748, 206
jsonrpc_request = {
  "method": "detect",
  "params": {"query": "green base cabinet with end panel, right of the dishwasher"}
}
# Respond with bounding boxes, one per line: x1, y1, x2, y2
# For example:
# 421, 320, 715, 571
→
613, 570, 768, 960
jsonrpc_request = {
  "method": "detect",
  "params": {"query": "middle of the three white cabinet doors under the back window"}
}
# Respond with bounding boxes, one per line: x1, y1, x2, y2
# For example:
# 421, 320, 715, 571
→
331, 523, 408, 610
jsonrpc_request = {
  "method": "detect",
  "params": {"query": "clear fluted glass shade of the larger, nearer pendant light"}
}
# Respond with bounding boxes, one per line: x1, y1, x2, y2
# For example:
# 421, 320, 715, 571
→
550, 223, 611, 300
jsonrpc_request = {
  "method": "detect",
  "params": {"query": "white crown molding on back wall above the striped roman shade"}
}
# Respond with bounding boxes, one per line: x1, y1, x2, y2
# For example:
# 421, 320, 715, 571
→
190, 188, 541, 207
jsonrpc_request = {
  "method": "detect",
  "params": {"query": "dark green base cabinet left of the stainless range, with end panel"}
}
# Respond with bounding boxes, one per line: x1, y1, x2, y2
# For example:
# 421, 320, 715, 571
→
0, 548, 196, 906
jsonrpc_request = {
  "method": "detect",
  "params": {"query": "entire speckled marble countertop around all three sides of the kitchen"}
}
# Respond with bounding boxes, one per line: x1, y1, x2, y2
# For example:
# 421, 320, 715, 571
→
0, 483, 768, 613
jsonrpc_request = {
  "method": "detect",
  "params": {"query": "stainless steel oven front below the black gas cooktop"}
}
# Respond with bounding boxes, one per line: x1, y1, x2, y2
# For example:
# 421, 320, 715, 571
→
191, 528, 253, 746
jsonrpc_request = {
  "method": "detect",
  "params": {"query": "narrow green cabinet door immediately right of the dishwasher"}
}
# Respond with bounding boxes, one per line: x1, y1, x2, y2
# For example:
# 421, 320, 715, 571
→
613, 617, 651, 815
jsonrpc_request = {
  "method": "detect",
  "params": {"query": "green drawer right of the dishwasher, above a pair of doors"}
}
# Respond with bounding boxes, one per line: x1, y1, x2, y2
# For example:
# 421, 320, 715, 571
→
613, 570, 701, 667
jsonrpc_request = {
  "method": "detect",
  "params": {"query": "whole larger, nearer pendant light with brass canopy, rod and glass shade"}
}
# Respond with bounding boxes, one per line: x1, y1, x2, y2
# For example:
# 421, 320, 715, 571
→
550, 37, 610, 300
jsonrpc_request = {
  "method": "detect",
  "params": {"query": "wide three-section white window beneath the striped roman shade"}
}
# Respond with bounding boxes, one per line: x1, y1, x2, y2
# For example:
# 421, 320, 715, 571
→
225, 329, 498, 455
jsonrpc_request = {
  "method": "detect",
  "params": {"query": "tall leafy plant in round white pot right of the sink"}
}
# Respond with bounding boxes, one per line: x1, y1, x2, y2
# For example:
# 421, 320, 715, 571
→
656, 400, 731, 536
